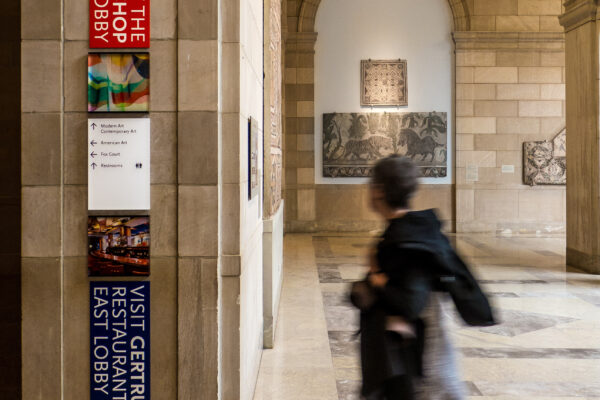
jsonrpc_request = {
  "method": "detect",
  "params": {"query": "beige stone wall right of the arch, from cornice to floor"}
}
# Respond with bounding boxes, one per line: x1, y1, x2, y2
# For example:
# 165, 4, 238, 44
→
455, 33, 565, 232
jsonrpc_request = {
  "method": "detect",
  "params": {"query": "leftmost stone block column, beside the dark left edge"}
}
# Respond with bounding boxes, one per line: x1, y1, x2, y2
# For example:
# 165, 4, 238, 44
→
21, 0, 64, 400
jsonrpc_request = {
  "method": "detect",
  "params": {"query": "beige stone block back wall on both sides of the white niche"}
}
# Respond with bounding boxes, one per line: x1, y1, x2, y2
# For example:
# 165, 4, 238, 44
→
284, 0, 565, 232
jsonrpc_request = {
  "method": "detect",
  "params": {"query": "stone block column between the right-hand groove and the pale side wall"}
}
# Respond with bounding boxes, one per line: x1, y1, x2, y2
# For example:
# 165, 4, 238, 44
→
177, 0, 222, 400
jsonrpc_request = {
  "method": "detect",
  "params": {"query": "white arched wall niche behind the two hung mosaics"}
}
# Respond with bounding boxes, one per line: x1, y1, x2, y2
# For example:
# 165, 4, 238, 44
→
315, 0, 454, 184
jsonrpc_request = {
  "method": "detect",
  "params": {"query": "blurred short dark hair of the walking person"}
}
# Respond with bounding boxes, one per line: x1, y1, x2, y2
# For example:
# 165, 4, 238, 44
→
372, 155, 419, 209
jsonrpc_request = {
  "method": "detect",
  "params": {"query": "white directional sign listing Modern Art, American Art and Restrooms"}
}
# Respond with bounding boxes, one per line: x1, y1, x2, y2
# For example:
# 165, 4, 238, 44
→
87, 118, 150, 210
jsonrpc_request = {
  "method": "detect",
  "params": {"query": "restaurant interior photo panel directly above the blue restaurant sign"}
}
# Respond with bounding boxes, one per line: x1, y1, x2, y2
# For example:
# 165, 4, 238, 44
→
88, 215, 150, 276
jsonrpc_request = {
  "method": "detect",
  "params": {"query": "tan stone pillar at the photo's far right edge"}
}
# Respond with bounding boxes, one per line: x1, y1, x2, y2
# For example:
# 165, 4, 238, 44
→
560, 0, 600, 274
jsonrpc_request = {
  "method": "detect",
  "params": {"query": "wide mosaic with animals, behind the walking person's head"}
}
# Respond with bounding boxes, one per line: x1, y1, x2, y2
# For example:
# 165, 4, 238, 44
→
323, 112, 448, 178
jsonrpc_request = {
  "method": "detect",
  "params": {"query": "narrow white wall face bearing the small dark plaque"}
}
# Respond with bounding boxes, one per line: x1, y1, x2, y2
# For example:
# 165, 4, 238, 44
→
239, 0, 263, 400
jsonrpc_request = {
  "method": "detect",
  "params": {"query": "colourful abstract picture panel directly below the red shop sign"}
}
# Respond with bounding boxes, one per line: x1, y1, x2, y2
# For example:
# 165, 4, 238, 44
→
88, 53, 150, 112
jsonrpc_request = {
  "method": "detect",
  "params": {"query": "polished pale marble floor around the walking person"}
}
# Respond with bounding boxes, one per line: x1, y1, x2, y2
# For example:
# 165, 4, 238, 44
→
254, 235, 600, 400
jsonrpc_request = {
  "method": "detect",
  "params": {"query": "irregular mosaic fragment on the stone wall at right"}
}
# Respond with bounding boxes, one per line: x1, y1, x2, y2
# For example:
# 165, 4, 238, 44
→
523, 129, 567, 186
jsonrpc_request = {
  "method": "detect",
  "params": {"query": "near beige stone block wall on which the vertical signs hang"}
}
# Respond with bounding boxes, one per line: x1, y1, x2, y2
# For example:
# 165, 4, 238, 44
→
21, 0, 262, 400
